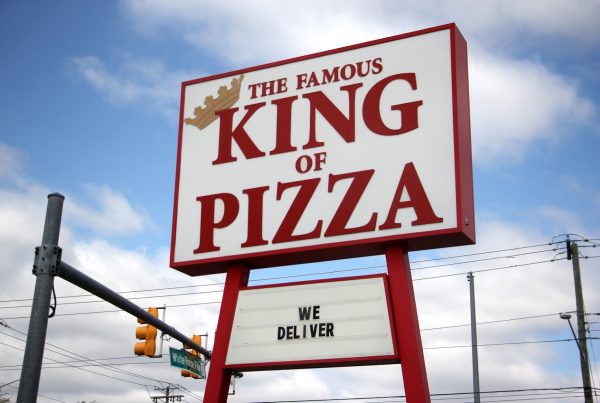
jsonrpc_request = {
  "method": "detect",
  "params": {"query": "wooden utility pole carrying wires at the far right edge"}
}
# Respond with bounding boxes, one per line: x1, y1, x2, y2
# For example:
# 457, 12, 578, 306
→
567, 238, 594, 403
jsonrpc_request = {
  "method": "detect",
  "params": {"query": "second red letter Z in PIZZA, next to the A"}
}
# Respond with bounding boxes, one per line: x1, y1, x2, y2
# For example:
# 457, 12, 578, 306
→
324, 169, 377, 237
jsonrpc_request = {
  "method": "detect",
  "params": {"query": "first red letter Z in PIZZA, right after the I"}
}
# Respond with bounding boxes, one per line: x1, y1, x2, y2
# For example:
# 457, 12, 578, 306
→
273, 178, 323, 243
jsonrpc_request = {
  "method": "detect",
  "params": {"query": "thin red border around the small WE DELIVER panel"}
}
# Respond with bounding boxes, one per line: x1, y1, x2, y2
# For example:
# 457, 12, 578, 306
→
225, 274, 400, 371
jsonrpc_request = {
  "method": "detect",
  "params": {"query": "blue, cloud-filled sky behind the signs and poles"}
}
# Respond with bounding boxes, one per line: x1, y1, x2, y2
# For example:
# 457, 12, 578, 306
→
0, 0, 600, 403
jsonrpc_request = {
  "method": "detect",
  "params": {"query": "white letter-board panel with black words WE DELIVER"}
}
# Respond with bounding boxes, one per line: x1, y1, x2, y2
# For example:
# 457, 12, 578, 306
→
226, 276, 395, 367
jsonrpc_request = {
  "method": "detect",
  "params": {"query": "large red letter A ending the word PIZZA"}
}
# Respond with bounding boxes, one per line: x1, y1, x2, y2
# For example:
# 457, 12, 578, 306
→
379, 162, 444, 229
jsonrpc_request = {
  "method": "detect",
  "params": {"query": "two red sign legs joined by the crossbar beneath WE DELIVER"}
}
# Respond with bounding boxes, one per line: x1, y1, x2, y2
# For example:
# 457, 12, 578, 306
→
204, 244, 431, 403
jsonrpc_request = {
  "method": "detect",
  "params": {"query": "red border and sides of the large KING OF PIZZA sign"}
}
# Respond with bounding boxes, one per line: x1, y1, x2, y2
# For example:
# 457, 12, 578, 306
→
170, 23, 475, 276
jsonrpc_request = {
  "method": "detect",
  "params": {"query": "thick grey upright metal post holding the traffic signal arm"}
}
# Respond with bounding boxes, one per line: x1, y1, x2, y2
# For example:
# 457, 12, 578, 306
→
17, 193, 65, 403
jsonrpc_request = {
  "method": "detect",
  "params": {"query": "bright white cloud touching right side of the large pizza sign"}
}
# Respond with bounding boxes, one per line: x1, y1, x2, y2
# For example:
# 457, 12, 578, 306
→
469, 52, 597, 165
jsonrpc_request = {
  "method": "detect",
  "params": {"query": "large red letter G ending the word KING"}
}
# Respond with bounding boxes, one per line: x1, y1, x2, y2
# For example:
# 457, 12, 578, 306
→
363, 73, 423, 136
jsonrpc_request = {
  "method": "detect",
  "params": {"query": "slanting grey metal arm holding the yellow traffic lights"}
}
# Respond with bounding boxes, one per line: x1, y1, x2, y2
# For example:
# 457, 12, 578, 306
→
58, 262, 211, 360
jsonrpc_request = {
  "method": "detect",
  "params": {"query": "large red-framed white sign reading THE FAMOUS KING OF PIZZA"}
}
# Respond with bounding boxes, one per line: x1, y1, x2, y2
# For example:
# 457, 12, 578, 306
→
171, 24, 475, 275
